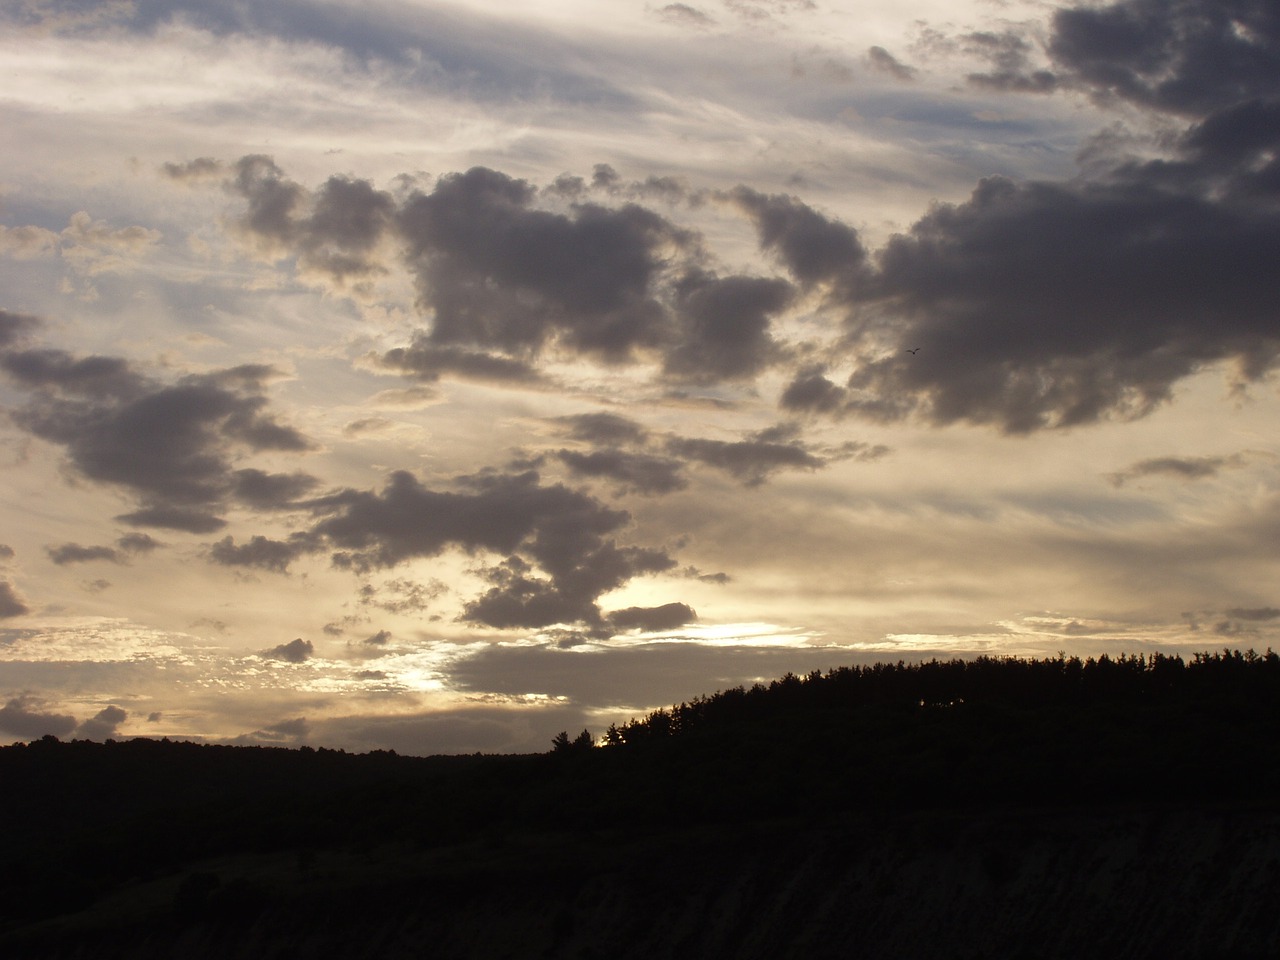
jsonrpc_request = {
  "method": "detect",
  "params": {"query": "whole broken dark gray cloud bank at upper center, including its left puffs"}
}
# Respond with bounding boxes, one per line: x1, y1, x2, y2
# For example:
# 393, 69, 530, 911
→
220, 156, 803, 381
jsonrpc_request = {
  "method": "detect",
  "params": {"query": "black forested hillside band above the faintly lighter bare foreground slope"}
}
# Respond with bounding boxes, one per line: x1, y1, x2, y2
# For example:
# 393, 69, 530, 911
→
0, 650, 1280, 954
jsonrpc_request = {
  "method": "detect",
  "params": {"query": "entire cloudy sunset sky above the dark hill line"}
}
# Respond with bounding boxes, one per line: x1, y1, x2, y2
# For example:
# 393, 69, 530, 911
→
0, 0, 1280, 754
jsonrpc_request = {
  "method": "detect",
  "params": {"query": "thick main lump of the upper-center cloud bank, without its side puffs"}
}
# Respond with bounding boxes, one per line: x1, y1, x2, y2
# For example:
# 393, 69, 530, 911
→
398, 168, 686, 361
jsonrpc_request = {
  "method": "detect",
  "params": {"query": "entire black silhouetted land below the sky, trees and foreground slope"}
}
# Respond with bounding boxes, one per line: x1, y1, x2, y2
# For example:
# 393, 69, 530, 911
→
0, 654, 1280, 960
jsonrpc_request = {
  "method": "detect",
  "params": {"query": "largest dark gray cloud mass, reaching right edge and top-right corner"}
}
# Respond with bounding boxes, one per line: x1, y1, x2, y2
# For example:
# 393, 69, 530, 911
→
768, 0, 1280, 433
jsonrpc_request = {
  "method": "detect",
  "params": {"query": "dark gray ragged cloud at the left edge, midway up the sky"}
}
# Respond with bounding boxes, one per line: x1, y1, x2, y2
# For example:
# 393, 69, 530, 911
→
0, 349, 314, 529
